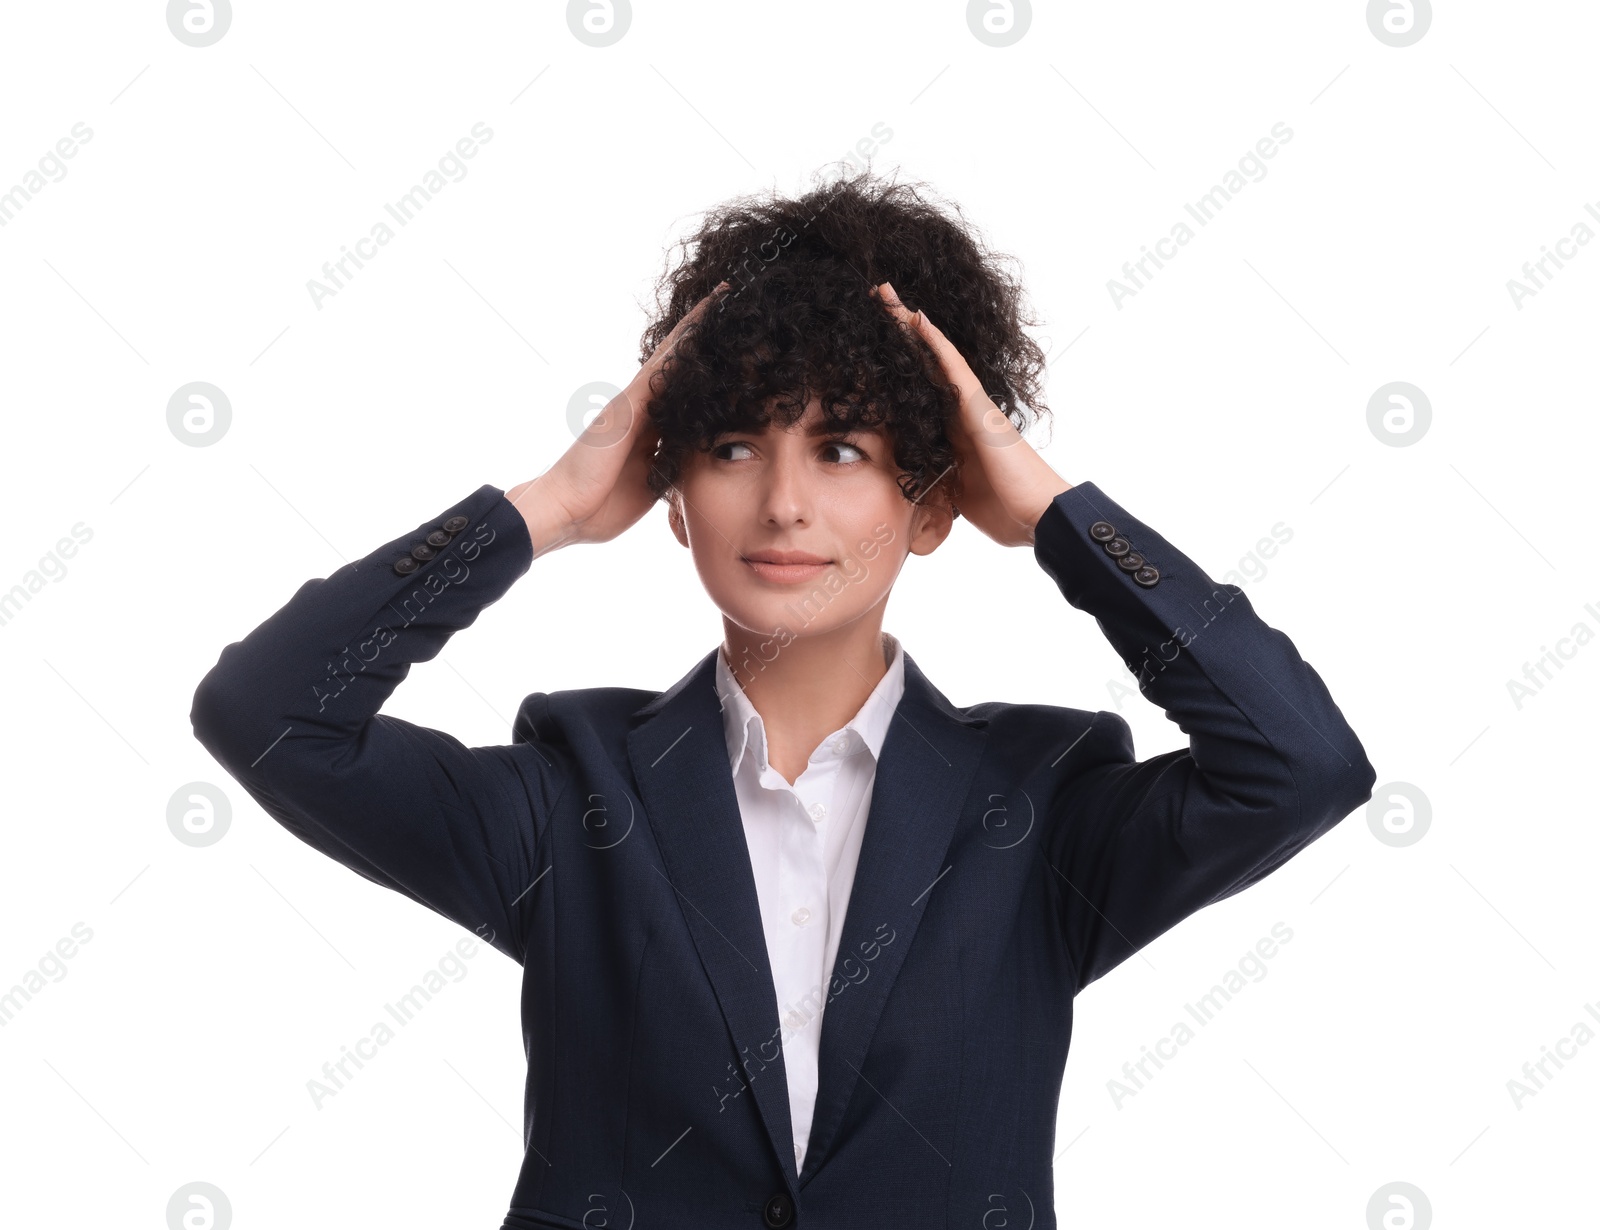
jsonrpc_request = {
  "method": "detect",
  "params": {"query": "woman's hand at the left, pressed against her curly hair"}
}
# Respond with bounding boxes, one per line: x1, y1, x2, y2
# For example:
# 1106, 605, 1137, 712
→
506, 282, 728, 555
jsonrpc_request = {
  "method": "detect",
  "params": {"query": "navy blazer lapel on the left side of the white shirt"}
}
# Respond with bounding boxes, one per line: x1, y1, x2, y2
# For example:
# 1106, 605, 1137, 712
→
627, 649, 797, 1182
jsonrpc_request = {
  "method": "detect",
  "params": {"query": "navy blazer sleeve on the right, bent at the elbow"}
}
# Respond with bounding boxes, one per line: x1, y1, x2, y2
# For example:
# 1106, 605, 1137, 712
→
1034, 483, 1376, 990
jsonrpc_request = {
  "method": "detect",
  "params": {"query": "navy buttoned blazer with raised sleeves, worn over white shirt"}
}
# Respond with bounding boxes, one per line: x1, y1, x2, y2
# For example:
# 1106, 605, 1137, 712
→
190, 483, 1374, 1230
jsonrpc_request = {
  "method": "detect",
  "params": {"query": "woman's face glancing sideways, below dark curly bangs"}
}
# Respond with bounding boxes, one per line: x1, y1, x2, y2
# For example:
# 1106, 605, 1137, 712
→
669, 398, 950, 637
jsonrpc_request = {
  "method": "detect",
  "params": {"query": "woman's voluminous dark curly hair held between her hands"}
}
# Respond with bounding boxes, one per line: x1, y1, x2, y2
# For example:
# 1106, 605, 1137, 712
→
640, 170, 1050, 501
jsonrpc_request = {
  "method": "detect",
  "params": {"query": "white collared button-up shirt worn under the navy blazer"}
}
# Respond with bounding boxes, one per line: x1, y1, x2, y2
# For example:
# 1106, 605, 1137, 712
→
717, 632, 906, 1171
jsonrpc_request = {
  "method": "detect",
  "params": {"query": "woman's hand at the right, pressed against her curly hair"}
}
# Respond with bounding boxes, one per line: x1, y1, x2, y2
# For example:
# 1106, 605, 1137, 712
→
875, 282, 1072, 547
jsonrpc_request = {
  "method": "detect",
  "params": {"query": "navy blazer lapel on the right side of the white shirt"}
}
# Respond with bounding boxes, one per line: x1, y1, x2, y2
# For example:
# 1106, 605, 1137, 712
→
802, 654, 987, 1184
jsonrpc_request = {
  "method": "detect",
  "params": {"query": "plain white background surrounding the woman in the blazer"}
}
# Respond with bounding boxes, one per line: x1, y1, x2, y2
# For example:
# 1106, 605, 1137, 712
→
0, 0, 1600, 1230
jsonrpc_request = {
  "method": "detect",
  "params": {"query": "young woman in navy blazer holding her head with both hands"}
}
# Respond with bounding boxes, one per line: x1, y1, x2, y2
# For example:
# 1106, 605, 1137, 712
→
192, 176, 1374, 1230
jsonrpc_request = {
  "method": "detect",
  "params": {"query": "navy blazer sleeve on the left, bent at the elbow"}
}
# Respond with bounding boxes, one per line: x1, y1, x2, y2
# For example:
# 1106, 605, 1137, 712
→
189, 486, 562, 963
